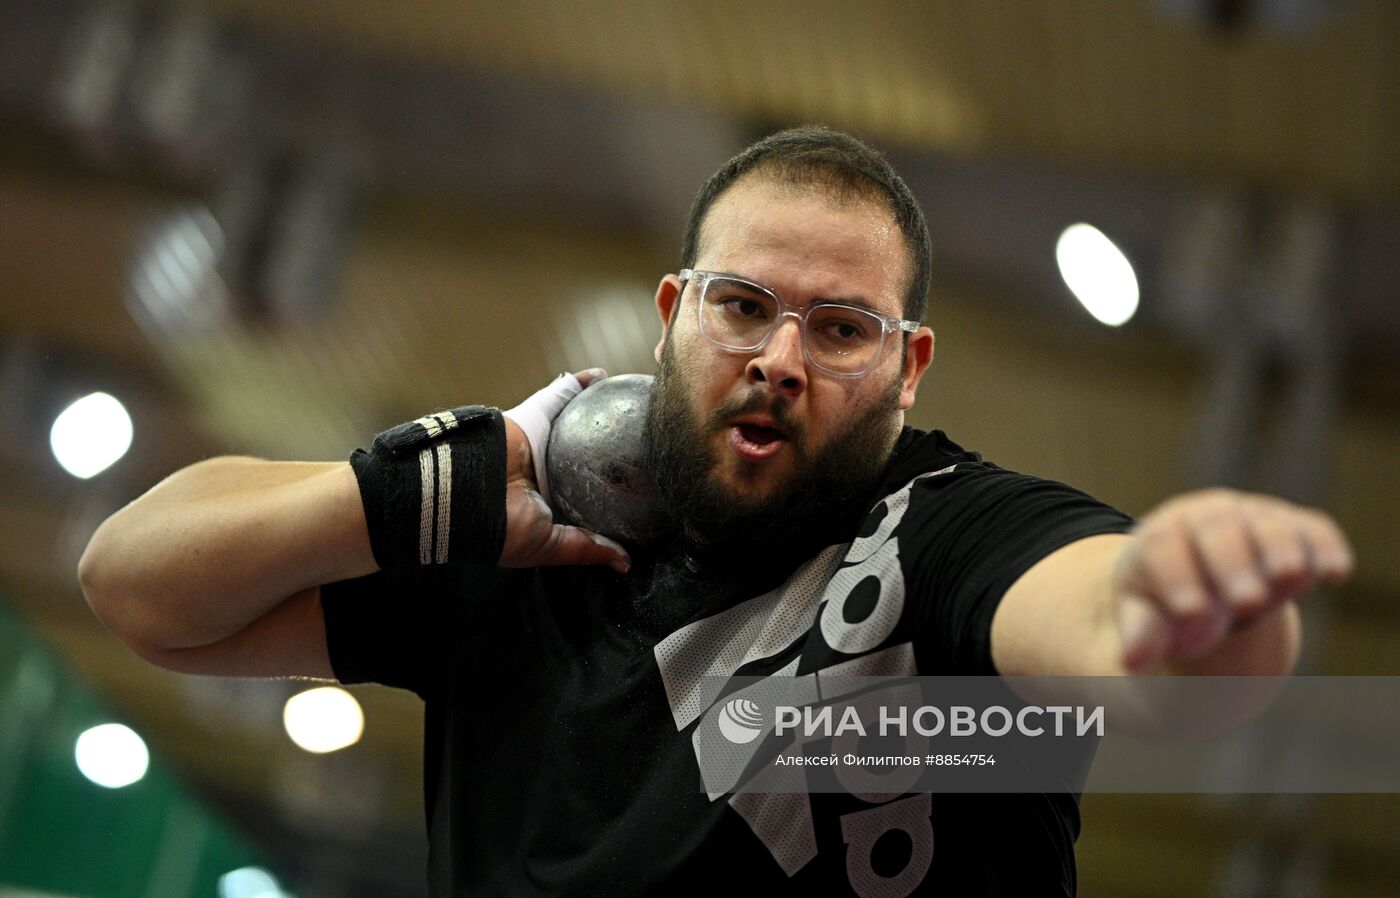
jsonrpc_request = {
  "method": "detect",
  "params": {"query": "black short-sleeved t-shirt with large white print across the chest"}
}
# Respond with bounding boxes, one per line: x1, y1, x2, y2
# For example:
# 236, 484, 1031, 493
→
322, 427, 1131, 898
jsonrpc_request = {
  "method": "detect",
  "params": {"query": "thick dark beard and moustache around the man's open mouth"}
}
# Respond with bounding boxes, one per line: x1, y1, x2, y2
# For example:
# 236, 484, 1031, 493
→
647, 339, 900, 566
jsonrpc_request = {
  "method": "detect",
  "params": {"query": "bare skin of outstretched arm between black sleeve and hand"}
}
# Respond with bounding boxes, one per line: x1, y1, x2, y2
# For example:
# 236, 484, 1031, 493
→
991, 534, 1130, 677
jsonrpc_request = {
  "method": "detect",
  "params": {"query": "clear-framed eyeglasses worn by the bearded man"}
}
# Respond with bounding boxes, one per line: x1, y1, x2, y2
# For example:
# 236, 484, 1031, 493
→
678, 268, 918, 377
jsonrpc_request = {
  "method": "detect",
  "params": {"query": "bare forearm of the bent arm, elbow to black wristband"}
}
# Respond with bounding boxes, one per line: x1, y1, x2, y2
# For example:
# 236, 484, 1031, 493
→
78, 457, 377, 650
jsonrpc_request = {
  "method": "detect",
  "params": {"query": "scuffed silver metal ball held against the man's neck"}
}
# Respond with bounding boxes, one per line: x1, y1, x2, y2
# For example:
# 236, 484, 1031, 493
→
545, 374, 657, 545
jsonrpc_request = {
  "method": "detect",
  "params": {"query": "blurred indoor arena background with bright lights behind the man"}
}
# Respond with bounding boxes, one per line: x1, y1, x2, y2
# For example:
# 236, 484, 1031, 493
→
0, 0, 1400, 898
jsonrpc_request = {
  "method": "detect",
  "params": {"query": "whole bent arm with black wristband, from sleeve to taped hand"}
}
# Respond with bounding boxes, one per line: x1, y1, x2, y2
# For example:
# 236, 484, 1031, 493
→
78, 368, 629, 678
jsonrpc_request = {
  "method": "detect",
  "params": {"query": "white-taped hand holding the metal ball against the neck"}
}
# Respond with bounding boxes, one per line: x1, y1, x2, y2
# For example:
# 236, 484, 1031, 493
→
500, 368, 631, 573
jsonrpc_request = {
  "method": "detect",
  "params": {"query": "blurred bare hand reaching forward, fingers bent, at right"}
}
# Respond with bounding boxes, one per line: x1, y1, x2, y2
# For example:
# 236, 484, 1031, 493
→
1113, 489, 1352, 672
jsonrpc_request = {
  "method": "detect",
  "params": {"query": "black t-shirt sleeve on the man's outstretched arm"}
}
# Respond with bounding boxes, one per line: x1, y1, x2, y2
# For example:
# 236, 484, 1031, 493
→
900, 462, 1134, 675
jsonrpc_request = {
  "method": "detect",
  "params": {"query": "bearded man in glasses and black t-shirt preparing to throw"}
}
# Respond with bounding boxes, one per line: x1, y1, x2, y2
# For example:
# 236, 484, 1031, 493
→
80, 127, 1351, 897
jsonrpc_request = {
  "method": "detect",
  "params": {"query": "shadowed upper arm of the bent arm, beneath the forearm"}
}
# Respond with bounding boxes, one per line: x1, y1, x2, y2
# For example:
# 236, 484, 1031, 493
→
136, 586, 335, 679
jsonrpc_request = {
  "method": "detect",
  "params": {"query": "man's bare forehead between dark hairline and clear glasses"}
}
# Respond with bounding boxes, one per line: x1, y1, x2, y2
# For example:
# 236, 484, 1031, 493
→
694, 177, 911, 315
